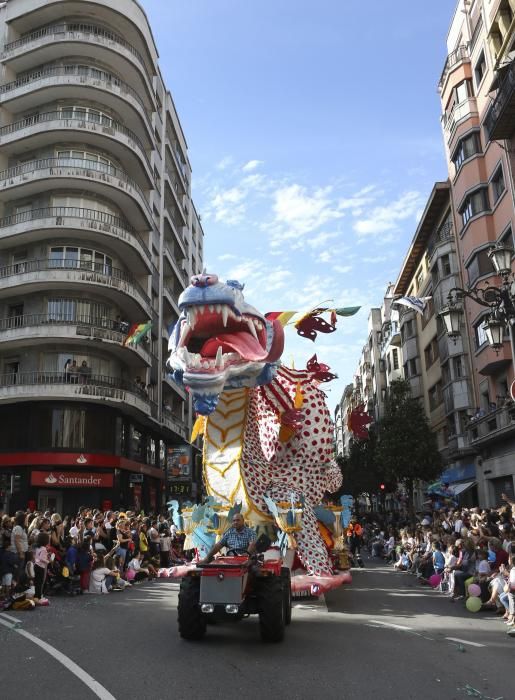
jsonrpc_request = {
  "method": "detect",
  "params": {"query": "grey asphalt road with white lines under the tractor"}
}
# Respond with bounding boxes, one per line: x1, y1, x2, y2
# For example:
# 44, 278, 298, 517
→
0, 562, 515, 700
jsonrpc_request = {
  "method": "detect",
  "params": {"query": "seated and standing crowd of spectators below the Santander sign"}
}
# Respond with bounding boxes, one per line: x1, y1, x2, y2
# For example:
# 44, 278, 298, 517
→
0, 507, 182, 609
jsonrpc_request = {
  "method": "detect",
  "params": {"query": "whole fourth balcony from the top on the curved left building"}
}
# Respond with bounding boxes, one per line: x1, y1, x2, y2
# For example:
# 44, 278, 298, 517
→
0, 158, 153, 229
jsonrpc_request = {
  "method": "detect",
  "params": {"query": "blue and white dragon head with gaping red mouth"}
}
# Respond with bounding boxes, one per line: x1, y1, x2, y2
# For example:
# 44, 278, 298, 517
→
167, 273, 284, 415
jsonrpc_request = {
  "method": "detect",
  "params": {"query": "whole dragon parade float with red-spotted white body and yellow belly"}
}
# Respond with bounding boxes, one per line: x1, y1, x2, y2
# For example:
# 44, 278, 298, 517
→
167, 273, 357, 595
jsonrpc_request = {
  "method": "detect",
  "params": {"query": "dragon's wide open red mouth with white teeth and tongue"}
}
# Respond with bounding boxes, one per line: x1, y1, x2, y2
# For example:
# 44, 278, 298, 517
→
176, 304, 268, 372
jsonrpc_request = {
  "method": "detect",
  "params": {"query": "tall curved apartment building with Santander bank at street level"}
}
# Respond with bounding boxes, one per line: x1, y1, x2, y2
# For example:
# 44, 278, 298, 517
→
0, 0, 203, 512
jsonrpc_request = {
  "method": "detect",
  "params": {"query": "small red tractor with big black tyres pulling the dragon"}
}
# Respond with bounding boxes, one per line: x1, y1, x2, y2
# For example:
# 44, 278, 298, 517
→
178, 550, 291, 642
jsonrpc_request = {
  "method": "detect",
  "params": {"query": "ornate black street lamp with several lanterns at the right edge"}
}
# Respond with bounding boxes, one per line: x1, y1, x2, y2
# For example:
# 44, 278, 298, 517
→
438, 244, 515, 366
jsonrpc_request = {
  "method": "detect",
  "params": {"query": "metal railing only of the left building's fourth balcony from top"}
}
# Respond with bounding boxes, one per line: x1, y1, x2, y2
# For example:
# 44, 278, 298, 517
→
0, 158, 150, 212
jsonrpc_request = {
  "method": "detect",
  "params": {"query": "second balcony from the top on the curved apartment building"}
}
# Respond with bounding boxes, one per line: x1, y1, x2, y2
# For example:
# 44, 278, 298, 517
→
0, 65, 153, 149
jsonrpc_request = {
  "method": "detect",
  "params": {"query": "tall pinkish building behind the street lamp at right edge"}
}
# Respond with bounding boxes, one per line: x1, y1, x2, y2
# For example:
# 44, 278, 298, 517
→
439, 0, 515, 506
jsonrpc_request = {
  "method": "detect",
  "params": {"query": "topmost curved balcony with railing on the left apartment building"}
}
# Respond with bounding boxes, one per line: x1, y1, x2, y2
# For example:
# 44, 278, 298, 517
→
2, 22, 153, 109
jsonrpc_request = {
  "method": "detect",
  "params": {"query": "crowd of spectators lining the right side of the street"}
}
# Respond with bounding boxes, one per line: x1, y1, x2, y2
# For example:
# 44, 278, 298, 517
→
354, 494, 515, 636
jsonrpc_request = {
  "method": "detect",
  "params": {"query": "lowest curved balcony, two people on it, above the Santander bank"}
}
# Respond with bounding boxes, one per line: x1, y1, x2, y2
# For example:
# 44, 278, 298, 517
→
0, 372, 153, 416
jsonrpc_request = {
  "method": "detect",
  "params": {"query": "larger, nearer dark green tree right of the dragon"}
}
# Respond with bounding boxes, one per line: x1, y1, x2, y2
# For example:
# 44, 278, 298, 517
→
375, 379, 442, 495
